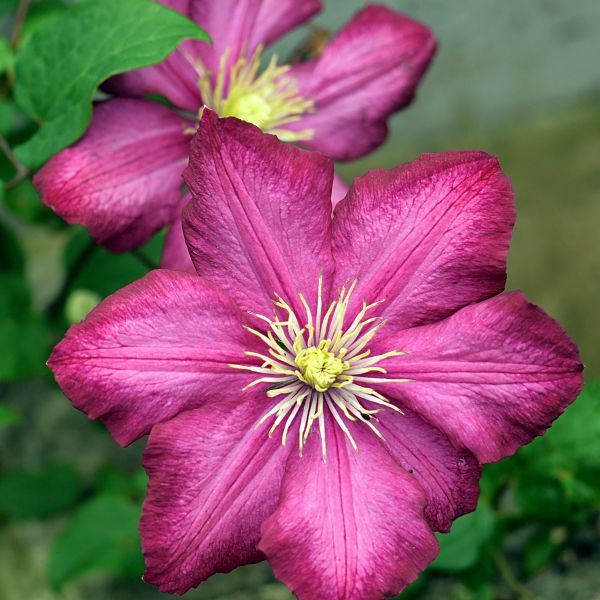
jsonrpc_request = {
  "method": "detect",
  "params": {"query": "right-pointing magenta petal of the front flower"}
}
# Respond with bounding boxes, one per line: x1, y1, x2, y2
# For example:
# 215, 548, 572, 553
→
380, 292, 582, 462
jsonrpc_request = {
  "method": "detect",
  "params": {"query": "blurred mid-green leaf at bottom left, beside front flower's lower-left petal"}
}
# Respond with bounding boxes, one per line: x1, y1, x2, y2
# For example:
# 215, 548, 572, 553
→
48, 495, 144, 589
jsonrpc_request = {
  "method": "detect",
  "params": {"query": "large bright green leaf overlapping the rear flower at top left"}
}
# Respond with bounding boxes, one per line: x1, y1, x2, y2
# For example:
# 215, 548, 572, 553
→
15, 0, 210, 167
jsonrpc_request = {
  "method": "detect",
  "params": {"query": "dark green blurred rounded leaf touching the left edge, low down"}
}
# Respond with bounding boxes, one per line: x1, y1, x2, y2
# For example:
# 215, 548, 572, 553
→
0, 464, 84, 519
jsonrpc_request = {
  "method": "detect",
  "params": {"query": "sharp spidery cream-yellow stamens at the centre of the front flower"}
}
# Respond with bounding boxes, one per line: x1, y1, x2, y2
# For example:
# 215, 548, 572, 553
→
229, 279, 411, 460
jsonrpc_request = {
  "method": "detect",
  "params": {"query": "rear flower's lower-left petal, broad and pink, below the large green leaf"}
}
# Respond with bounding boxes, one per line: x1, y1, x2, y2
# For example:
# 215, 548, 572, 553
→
34, 99, 190, 252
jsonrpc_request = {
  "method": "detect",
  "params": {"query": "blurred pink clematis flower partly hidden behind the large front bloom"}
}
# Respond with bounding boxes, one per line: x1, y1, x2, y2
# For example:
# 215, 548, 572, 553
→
34, 0, 436, 255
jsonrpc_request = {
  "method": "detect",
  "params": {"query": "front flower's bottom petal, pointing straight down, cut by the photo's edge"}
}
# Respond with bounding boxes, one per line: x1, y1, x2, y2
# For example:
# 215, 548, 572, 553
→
259, 420, 438, 600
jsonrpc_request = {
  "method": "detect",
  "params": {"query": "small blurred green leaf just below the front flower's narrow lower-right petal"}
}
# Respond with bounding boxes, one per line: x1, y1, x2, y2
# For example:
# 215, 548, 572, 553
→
431, 502, 495, 573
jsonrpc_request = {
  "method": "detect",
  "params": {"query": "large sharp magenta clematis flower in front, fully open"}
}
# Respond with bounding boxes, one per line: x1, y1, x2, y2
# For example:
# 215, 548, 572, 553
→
49, 110, 582, 600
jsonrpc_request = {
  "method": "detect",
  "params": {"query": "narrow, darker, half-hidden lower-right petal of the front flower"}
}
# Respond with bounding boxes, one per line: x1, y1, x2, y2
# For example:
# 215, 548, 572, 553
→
377, 408, 481, 532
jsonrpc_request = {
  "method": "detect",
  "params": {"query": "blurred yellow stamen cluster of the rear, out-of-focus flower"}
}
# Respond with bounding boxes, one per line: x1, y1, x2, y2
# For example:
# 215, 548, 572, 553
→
198, 47, 315, 142
